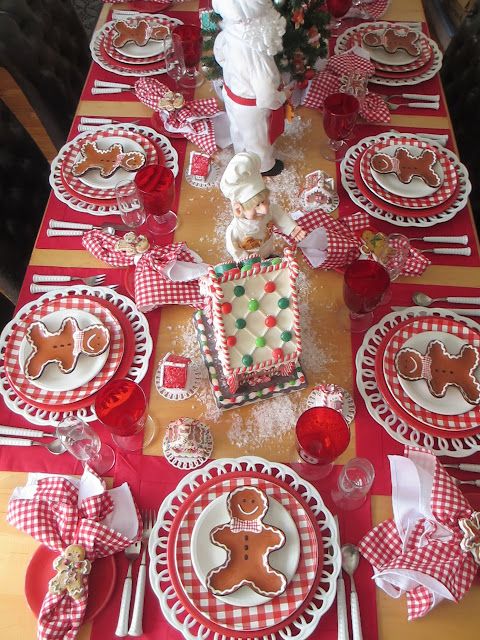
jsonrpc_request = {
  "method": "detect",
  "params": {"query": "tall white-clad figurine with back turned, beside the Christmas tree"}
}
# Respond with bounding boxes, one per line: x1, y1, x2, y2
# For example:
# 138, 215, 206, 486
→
212, 0, 286, 176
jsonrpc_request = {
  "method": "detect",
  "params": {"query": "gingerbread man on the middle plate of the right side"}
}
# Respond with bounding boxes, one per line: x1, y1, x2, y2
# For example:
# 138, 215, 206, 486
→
370, 147, 442, 187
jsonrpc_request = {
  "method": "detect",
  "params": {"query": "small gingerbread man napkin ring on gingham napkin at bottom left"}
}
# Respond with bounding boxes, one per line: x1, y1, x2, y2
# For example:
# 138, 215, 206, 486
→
48, 544, 92, 600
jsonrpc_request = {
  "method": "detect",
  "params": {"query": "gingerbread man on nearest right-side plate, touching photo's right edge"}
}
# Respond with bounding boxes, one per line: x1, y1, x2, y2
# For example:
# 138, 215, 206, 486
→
395, 340, 480, 405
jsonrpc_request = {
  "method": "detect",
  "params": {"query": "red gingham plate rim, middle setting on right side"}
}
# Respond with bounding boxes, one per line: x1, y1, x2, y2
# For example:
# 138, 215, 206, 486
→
358, 136, 458, 210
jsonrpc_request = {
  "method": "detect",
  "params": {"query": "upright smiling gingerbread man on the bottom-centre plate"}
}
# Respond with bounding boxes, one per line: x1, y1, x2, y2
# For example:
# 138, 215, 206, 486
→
206, 487, 287, 598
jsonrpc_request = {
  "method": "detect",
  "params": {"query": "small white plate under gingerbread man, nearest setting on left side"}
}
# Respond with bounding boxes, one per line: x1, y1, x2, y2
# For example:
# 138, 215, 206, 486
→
18, 309, 110, 391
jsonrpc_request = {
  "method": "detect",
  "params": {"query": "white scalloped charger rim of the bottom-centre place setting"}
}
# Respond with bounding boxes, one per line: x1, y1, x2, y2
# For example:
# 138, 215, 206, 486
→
148, 456, 341, 640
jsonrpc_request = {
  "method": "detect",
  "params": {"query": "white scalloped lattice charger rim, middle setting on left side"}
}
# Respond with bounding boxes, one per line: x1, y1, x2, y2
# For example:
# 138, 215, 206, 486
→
49, 122, 178, 216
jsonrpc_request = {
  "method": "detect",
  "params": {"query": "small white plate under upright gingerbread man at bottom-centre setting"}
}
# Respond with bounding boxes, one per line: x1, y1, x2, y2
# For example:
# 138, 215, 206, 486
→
191, 494, 300, 607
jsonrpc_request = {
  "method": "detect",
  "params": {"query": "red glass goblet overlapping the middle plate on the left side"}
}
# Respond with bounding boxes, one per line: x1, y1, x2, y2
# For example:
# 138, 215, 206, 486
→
135, 165, 178, 236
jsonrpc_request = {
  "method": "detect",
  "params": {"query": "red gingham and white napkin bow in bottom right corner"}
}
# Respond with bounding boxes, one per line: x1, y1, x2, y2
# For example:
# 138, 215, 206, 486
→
359, 449, 478, 620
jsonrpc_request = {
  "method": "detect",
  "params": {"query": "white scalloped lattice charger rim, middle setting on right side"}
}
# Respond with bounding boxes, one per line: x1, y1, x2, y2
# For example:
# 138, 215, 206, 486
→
340, 131, 472, 227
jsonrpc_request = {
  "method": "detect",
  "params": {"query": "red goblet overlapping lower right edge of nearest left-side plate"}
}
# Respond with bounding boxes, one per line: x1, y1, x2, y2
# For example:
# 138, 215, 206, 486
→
95, 378, 155, 451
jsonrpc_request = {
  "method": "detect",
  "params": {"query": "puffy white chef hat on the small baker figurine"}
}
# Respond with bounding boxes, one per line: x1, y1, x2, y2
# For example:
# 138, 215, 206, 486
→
220, 151, 266, 204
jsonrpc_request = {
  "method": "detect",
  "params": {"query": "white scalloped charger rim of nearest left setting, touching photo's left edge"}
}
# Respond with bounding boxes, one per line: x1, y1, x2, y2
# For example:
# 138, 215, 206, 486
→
0, 285, 153, 427
